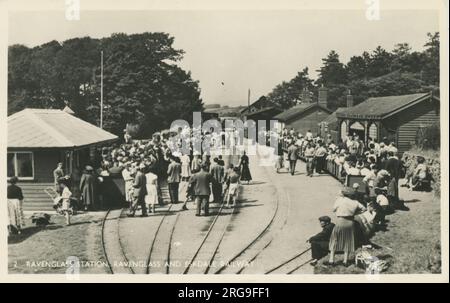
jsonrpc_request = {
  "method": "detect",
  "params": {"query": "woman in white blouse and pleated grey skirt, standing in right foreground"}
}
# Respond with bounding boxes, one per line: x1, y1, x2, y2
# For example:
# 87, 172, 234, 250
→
326, 189, 366, 266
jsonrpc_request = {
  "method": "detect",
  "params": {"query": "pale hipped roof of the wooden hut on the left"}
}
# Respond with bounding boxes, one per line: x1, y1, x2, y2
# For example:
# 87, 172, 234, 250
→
8, 109, 118, 148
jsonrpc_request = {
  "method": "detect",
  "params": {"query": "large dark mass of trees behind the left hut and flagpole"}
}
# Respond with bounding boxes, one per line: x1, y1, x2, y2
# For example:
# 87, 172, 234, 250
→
8, 33, 203, 137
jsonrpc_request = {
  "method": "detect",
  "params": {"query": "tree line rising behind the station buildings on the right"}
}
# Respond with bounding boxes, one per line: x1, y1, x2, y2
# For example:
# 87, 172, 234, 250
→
267, 33, 439, 109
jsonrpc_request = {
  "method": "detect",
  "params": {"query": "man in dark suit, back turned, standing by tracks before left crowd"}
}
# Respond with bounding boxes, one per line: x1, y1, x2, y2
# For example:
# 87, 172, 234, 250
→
189, 164, 214, 216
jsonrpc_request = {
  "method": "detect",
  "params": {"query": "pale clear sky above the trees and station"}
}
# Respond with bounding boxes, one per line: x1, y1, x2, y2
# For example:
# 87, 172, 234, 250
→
8, 10, 439, 106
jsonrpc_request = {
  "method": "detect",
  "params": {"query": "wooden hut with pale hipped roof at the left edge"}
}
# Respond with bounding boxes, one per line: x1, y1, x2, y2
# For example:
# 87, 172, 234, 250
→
7, 109, 118, 210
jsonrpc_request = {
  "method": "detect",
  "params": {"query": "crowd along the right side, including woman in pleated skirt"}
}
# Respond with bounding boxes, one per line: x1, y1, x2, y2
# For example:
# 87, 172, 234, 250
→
276, 128, 429, 266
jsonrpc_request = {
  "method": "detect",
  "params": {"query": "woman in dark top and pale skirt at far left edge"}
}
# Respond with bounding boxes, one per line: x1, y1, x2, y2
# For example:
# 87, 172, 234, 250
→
7, 176, 25, 234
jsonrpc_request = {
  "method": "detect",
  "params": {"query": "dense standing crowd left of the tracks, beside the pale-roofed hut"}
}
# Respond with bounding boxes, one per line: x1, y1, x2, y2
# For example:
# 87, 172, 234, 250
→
65, 128, 252, 217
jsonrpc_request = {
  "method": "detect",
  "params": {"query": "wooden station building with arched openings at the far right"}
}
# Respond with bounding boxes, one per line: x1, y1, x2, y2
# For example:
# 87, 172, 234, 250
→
336, 93, 440, 152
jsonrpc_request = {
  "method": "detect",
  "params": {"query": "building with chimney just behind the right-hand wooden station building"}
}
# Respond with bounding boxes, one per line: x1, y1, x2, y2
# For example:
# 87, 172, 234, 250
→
273, 87, 333, 135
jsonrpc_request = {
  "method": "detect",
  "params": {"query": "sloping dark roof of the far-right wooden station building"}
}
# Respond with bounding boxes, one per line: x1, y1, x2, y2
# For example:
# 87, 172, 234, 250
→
337, 93, 431, 119
